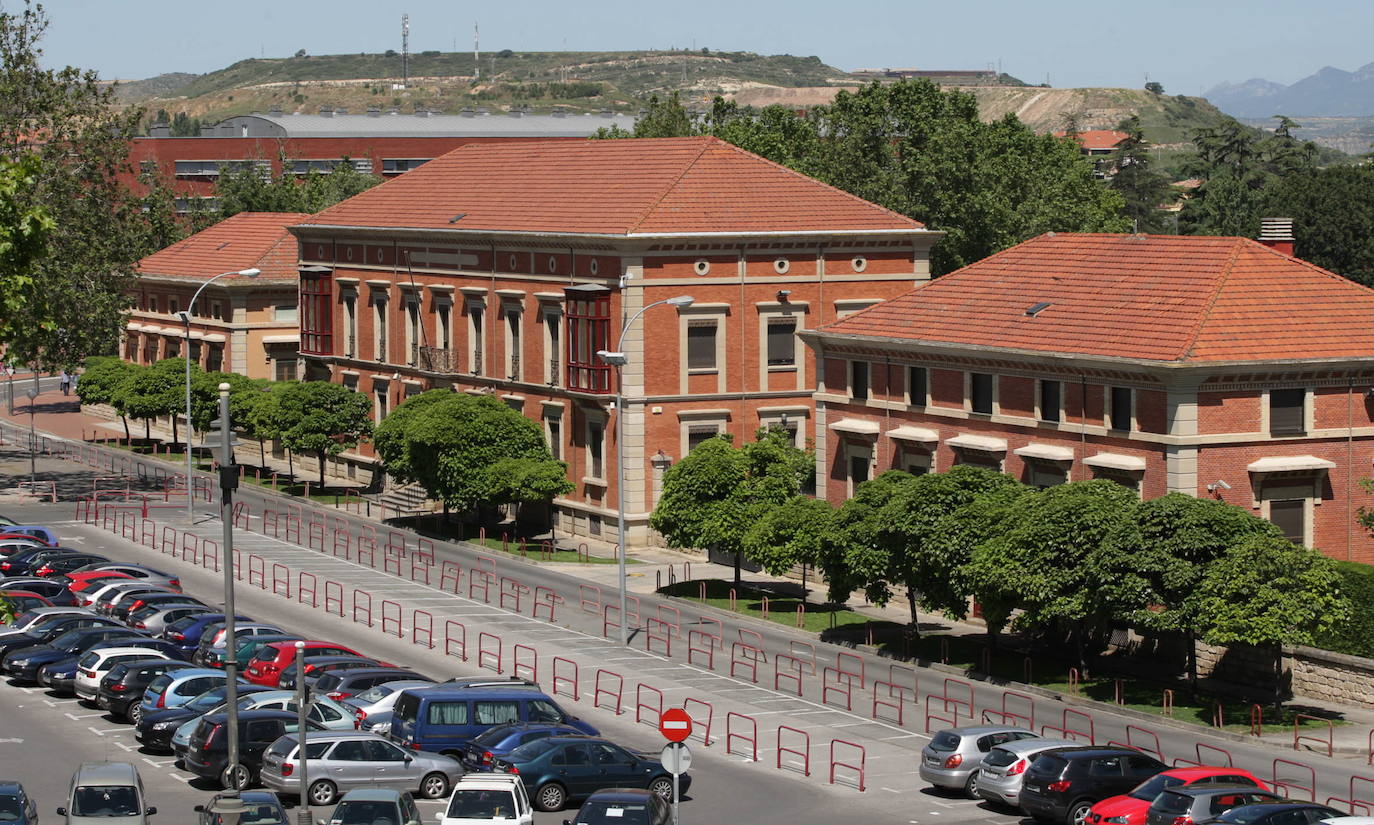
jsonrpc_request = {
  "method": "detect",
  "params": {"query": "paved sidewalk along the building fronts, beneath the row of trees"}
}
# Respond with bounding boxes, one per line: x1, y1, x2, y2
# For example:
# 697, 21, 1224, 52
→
8, 391, 1374, 755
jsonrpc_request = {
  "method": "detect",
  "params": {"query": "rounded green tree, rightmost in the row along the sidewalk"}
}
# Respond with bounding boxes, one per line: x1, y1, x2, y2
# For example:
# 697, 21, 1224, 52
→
1197, 535, 1351, 694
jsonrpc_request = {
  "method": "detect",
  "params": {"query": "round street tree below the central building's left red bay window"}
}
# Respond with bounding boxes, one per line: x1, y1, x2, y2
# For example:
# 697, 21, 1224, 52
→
276, 381, 372, 487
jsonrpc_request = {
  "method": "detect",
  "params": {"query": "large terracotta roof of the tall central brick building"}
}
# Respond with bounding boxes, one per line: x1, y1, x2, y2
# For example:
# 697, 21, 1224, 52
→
305, 138, 922, 235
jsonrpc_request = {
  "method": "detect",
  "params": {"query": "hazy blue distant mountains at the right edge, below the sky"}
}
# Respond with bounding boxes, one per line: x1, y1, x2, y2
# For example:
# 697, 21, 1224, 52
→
1204, 63, 1374, 118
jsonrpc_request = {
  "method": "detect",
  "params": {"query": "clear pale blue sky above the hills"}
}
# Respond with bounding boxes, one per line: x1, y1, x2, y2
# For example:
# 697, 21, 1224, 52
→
18, 0, 1374, 95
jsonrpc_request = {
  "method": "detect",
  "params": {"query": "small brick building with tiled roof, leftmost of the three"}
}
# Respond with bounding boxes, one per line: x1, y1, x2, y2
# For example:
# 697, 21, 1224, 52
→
124, 212, 308, 381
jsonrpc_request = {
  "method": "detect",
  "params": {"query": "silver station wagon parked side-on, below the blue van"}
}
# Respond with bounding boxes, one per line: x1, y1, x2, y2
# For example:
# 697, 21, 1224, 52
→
260, 730, 463, 807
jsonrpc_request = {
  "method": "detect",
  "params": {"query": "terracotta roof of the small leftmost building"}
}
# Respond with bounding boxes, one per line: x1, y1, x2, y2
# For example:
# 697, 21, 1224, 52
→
137, 212, 309, 283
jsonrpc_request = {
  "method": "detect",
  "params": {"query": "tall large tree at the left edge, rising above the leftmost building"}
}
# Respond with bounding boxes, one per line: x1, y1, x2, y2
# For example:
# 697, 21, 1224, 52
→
0, 3, 146, 369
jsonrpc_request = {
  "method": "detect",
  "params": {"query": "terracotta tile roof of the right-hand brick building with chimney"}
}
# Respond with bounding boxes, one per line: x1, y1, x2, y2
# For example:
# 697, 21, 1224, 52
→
820, 232, 1374, 363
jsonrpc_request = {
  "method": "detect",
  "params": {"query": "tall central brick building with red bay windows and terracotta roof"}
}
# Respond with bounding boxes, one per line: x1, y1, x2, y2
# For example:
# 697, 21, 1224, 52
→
291, 138, 938, 543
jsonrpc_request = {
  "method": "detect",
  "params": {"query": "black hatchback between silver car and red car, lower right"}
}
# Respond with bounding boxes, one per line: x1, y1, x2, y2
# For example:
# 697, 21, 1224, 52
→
1020, 745, 1168, 825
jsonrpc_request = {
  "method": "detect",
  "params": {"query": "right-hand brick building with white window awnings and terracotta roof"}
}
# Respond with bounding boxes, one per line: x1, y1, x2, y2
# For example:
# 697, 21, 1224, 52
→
804, 227, 1374, 562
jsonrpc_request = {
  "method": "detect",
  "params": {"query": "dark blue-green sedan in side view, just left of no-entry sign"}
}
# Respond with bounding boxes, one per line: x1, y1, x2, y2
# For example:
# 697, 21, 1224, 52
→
495, 736, 691, 811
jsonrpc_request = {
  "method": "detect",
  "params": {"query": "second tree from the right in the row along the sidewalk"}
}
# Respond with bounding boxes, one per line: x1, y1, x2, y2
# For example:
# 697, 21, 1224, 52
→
1099, 492, 1282, 686
